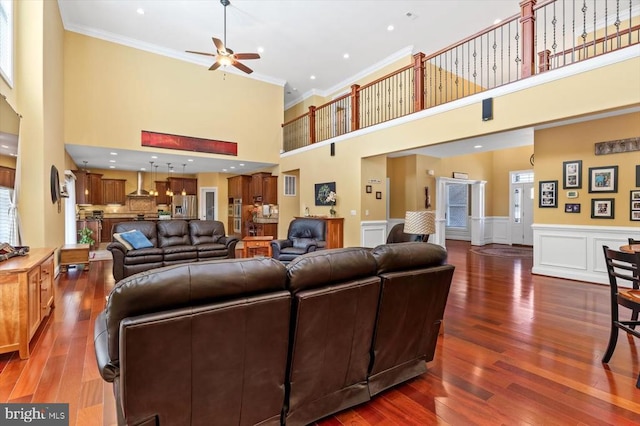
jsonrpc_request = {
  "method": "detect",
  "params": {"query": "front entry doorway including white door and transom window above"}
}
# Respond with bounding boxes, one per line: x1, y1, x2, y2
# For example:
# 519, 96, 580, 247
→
509, 170, 534, 246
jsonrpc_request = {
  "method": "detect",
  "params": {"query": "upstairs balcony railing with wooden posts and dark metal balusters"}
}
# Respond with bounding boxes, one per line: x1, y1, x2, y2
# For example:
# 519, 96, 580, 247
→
282, 0, 640, 151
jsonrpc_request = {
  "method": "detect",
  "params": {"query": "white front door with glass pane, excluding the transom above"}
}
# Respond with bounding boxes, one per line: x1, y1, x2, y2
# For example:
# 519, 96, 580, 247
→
510, 182, 534, 246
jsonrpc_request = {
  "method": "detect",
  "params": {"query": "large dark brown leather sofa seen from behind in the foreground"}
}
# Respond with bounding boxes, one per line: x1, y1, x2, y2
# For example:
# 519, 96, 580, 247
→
95, 242, 454, 425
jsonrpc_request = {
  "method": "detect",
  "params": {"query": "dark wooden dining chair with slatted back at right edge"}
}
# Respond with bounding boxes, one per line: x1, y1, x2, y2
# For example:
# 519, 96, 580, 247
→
602, 246, 640, 388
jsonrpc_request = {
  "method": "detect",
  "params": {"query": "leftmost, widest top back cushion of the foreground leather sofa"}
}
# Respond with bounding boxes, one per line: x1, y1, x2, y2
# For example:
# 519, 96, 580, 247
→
106, 257, 287, 362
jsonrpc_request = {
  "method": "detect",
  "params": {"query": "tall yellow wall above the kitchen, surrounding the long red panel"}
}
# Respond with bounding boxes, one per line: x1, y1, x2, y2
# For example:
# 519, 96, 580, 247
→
64, 32, 283, 164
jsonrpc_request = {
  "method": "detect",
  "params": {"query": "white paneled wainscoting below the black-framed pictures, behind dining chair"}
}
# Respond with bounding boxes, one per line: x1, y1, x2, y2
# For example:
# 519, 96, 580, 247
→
532, 225, 640, 284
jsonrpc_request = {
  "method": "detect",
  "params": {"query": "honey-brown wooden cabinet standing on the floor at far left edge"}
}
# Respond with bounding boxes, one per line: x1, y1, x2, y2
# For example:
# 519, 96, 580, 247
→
0, 248, 55, 359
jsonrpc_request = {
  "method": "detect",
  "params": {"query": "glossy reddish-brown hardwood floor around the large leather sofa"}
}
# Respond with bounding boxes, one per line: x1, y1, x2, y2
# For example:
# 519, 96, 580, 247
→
0, 241, 640, 426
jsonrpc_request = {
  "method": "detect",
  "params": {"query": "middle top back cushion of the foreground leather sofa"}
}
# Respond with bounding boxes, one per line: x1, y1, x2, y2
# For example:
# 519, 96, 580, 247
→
287, 247, 376, 293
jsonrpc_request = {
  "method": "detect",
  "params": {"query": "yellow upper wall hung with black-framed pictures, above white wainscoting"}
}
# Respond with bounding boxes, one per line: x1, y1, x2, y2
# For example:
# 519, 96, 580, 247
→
534, 113, 640, 226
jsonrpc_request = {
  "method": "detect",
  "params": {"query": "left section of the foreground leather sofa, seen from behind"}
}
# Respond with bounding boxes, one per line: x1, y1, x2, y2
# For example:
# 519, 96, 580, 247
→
94, 258, 291, 426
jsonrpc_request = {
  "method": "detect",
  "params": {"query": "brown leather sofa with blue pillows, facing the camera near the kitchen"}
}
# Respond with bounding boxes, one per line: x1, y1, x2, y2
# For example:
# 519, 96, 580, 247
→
107, 219, 238, 281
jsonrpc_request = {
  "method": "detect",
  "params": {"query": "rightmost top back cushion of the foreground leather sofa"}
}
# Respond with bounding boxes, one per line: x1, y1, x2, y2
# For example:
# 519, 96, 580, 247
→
371, 242, 447, 274
